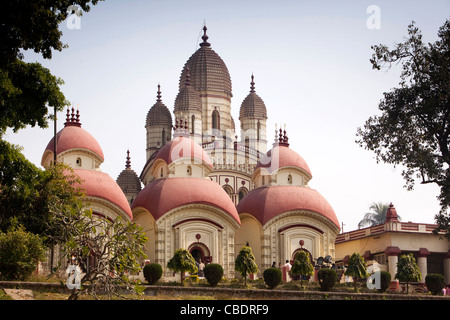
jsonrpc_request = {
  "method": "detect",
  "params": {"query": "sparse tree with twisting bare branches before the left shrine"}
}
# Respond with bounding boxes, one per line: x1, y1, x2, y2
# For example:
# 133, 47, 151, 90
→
51, 208, 147, 300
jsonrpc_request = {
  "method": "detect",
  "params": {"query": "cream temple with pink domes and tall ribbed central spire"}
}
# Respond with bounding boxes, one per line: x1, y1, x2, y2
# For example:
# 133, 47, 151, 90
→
41, 26, 450, 290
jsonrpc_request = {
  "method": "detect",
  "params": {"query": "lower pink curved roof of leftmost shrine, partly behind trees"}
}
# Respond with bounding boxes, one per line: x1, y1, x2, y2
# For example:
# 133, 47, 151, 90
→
74, 169, 133, 219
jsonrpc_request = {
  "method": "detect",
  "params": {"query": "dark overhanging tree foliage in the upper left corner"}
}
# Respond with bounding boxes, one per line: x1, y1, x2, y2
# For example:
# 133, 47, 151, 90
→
0, 0, 103, 136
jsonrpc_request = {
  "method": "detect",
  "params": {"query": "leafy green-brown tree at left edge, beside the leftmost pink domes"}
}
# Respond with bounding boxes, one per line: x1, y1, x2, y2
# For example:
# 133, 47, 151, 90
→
0, 155, 83, 238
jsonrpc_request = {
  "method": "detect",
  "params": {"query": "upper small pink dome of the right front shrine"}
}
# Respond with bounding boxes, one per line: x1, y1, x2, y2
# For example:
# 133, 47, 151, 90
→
255, 143, 312, 178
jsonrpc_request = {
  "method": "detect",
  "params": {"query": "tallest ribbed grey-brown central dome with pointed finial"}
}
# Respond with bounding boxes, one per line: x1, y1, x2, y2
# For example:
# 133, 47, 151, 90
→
179, 26, 232, 98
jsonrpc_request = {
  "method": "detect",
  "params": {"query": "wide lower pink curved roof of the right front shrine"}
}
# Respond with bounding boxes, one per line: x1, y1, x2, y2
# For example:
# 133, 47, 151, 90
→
237, 186, 340, 229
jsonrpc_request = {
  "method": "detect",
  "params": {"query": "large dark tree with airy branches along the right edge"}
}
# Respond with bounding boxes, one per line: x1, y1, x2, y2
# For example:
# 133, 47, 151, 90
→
356, 20, 450, 239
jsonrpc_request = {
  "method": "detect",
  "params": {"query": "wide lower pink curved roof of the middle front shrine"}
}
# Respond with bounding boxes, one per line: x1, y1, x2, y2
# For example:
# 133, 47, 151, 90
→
131, 178, 241, 224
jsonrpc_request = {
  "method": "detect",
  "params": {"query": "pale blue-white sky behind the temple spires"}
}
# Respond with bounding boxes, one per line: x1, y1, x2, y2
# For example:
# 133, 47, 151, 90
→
5, 0, 450, 232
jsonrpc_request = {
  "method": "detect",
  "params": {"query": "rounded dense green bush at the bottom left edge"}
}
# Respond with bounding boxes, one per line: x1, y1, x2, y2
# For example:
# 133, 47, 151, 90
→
0, 219, 45, 280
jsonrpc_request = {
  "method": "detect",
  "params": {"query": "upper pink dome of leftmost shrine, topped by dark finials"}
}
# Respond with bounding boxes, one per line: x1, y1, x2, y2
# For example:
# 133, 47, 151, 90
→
41, 108, 105, 166
